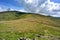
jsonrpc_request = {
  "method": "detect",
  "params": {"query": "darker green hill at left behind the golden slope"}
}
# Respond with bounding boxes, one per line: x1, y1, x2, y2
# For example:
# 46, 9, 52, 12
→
0, 11, 25, 21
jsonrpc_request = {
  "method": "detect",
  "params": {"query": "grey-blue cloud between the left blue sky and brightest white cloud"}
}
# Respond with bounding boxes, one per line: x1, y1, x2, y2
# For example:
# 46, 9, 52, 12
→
24, 0, 46, 13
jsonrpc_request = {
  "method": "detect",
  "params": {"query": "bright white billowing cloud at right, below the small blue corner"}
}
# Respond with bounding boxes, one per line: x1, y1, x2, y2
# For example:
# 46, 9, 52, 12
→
43, 1, 60, 17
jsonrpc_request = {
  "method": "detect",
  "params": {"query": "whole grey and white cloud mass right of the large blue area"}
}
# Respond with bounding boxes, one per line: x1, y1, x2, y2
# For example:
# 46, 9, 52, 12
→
20, 0, 60, 16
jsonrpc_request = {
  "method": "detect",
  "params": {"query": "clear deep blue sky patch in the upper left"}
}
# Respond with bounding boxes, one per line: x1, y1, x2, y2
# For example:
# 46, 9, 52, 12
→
0, 0, 22, 9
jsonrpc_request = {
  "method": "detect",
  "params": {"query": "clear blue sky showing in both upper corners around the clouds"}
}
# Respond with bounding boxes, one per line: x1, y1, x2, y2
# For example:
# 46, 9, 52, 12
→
0, 0, 60, 9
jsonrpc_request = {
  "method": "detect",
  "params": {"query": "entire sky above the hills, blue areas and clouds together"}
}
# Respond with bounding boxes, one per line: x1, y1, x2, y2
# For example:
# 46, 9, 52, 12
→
0, 0, 60, 17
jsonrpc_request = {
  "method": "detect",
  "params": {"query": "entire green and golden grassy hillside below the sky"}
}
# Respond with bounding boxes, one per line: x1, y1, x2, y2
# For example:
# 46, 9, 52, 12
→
0, 11, 60, 40
